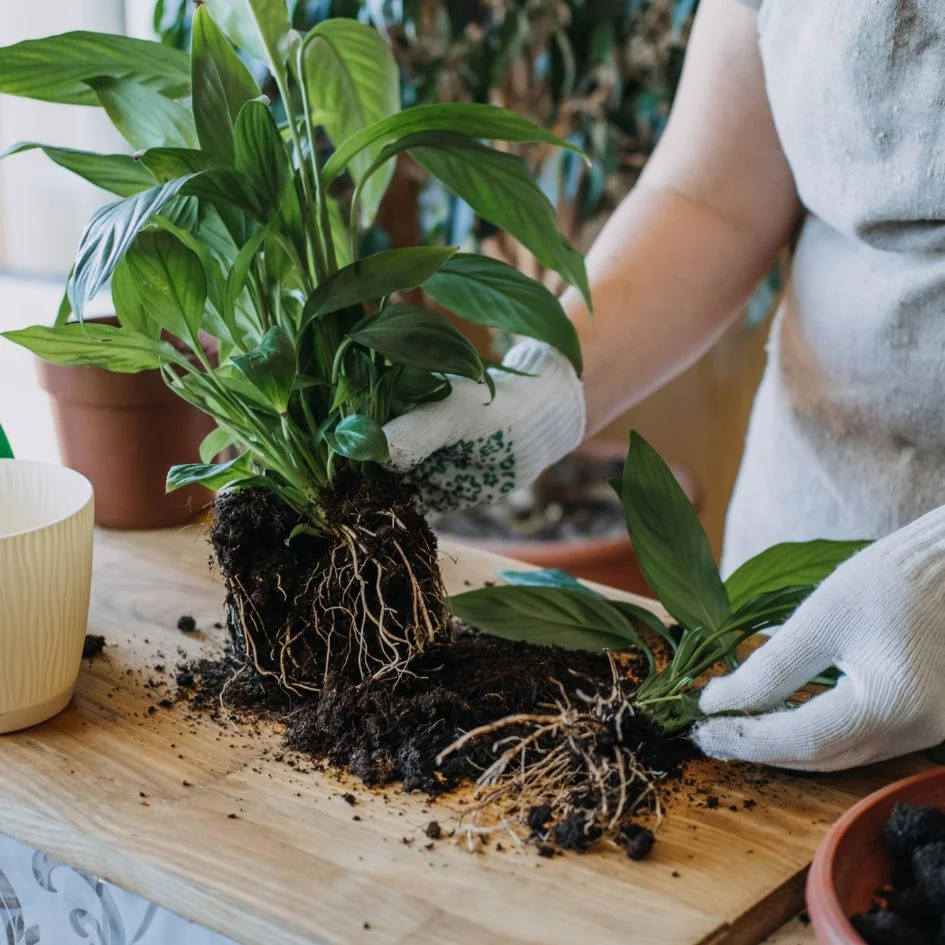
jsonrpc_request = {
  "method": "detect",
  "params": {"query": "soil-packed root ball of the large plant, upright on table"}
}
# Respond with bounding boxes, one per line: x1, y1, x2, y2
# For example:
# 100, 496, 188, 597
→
210, 475, 451, 695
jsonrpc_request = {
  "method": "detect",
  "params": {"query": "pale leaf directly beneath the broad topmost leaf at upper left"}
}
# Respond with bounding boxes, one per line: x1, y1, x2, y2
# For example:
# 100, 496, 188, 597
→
89, 76, 197, 150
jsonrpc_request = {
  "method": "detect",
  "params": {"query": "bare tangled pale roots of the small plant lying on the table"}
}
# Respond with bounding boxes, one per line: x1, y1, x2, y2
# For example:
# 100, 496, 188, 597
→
437, 658, 668, 859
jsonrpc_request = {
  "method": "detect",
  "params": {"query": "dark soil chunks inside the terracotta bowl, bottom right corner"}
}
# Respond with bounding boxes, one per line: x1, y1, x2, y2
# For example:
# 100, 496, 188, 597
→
851, 803, 945, 945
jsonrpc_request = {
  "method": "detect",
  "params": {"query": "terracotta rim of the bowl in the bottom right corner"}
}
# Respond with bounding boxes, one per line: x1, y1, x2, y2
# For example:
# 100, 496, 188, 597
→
805, 768, 945, 945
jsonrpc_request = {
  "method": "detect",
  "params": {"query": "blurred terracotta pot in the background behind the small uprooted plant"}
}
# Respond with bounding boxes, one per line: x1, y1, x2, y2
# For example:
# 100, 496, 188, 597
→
442, 440, 696, 596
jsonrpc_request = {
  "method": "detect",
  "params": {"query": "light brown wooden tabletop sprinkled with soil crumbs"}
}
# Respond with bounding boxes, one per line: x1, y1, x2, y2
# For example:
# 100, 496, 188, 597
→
0, 529, 924, 945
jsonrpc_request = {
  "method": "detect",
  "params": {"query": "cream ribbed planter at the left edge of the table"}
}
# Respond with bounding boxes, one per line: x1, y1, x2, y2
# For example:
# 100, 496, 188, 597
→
0, 459, 94, 733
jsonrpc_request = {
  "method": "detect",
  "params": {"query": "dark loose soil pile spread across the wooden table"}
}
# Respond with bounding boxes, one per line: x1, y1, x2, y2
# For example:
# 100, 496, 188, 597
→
177, 628, 694, 859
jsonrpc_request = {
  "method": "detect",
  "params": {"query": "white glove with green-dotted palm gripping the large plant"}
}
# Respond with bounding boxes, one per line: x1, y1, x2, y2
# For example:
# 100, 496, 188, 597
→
384, 341, 584, 512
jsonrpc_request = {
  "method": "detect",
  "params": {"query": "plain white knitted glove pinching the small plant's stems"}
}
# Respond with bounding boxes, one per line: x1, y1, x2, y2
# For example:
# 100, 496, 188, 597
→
694, 508, 945, 771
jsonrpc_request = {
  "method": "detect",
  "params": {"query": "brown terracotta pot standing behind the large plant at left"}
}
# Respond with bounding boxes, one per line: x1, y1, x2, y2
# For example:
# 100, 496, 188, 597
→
38, 318, 214, 529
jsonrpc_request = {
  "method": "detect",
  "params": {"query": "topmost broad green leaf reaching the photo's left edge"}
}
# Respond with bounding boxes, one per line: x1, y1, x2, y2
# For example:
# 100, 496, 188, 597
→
0, 31, 190, 105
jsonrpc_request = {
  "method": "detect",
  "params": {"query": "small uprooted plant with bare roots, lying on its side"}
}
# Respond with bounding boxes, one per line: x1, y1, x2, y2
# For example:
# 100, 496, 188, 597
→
441, 433, 866, 856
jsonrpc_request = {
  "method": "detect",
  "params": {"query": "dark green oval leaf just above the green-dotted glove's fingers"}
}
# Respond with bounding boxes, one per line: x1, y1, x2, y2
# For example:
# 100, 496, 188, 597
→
348, 303, 483, 381
